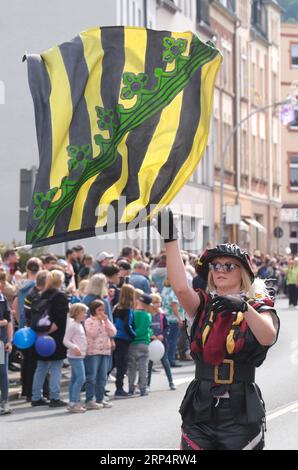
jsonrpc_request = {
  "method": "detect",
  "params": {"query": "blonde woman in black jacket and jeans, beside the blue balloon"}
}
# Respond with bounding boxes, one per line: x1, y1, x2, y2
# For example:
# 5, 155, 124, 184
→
31, 269, 68, 408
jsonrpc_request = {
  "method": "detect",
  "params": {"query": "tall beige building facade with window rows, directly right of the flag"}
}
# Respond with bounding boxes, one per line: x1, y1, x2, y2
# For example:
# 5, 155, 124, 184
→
197, 0, 281, 252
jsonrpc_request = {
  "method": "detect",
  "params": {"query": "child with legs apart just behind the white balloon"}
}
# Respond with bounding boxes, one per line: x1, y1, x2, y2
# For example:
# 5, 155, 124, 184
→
148, 294, 176, 390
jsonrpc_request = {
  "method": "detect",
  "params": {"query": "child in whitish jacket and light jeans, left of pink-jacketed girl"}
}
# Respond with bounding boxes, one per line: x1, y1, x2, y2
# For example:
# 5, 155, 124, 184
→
63, 303, 88, 413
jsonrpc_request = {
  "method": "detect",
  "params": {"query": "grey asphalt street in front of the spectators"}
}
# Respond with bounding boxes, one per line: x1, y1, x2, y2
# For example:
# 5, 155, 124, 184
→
0, 299, 298, 450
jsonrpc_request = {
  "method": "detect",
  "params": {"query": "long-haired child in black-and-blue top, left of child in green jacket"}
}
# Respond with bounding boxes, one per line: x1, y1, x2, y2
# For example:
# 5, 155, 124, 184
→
113, 284, 136, 398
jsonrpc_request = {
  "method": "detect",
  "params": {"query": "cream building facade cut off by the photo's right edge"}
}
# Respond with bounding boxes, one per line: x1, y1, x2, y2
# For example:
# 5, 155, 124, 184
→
280, 23, 298, 255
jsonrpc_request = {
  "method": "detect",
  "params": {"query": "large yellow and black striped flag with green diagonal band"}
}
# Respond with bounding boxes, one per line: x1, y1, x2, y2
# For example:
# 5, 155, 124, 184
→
26, 27, 222, 246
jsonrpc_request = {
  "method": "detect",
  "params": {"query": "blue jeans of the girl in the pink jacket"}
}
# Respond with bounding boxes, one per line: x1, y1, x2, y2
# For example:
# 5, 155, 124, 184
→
85, 354, 111, 403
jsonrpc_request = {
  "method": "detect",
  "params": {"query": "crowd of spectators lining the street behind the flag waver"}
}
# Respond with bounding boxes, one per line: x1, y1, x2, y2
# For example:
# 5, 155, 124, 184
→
0, 245, 298, 414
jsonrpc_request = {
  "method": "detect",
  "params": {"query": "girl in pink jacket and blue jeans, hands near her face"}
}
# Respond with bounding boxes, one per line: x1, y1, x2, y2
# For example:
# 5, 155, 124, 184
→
85, 299, 116, 410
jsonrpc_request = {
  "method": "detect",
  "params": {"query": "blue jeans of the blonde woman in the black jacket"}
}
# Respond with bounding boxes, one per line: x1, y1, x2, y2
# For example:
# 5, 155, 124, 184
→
32, 359, 63, 401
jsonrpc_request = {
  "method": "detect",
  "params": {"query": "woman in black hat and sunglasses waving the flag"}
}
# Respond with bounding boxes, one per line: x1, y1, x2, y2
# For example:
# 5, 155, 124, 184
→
158, 209, 279, 450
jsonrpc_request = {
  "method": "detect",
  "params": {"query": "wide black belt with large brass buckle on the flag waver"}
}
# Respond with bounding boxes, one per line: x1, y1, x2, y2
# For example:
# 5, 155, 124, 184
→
196, 359, 256, 385
